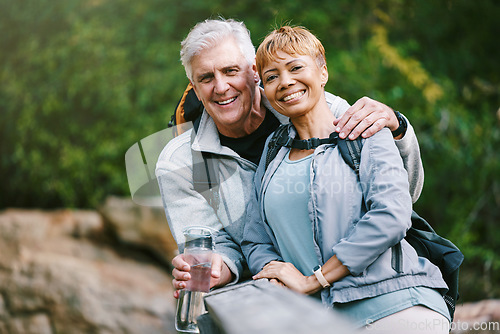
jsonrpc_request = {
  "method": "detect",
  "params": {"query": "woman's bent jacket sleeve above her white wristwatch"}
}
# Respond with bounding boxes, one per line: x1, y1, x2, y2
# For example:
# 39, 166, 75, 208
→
332, 129, 412, 275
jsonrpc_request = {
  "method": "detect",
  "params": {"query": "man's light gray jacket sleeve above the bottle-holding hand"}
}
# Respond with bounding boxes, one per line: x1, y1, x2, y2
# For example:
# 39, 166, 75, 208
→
156, 135, 245, 282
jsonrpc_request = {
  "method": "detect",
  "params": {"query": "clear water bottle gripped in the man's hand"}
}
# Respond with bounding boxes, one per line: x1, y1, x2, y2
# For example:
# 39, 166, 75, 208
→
175, 226, 214, 333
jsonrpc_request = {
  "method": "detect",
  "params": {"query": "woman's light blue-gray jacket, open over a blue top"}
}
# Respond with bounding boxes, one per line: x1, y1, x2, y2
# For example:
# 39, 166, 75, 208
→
242, 117, 447, 305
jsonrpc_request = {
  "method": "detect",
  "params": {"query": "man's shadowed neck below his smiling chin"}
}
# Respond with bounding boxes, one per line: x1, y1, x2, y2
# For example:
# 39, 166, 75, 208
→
218, 85, 266, 138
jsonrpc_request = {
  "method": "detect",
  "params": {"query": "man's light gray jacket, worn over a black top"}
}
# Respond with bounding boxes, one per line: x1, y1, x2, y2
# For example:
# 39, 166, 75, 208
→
156, 93, 424, 281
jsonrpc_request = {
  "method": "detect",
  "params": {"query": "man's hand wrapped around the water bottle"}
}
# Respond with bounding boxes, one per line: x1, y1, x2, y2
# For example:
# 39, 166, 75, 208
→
172, 253, 233, 298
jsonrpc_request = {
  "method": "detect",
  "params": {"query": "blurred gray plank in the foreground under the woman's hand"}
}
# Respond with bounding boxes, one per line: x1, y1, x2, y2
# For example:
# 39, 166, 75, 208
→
205, 280, 354, 334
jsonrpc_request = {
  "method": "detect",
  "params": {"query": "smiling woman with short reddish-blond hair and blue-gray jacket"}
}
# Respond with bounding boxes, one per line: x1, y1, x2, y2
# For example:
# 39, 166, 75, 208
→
242, 26, 450, 333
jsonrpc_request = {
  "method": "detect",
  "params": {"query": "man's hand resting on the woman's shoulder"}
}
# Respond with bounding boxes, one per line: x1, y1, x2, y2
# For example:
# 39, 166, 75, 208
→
333, 96, 403, 140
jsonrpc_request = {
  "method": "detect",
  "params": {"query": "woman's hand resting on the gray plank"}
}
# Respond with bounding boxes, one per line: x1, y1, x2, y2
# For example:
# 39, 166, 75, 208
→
253, 261, 321, 295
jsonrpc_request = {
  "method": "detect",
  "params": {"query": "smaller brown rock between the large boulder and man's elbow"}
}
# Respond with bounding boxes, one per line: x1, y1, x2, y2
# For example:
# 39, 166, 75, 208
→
99, 197, 177, 263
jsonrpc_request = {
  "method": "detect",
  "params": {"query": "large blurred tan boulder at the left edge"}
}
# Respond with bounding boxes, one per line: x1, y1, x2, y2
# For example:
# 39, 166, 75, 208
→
0, 210, 175, 334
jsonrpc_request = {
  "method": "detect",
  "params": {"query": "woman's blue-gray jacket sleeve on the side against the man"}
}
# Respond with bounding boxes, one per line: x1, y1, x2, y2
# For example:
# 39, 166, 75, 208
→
241, 138, 283, 275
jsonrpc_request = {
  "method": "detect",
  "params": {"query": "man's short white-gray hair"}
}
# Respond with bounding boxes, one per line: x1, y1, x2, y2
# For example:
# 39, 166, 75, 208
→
181, 18, 255, 81
